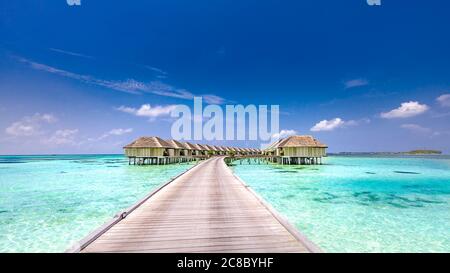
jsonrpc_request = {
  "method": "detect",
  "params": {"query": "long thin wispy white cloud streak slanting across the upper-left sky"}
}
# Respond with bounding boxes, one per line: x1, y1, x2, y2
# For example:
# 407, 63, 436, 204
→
16, 57, 225, 104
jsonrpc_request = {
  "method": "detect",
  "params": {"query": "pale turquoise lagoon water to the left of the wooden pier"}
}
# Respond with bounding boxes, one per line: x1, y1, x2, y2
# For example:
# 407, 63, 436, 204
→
0, 155, 192, 252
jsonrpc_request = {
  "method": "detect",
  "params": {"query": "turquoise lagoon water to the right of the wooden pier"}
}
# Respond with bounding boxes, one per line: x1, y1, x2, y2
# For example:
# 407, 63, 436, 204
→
233, 156, 450, 252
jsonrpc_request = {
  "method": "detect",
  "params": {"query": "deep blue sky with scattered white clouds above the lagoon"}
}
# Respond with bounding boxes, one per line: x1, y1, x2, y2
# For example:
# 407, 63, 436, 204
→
0, 0, 450, 154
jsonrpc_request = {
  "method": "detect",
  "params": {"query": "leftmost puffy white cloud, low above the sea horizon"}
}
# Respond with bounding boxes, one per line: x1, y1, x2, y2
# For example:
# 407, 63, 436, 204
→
5, 113, 57, 137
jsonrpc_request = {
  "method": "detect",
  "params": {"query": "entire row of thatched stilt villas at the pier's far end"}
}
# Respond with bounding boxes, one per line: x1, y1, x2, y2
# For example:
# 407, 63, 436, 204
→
124, 133, 327, 165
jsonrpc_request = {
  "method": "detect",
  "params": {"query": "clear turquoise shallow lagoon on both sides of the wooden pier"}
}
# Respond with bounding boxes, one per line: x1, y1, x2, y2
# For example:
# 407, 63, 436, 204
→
0, 155, 450, 252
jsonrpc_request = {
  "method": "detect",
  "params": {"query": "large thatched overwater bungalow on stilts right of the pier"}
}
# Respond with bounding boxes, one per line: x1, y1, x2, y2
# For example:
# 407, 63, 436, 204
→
265, 136, 328, 165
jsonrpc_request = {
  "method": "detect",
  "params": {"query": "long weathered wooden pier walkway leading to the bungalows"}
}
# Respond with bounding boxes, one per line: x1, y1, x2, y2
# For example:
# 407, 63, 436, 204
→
75, 157, 320, 253
